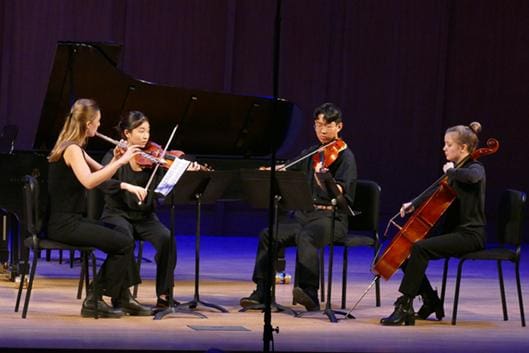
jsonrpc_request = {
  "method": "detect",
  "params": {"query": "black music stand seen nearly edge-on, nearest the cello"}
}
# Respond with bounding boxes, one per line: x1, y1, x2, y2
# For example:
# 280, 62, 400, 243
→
298, 173, 350, 322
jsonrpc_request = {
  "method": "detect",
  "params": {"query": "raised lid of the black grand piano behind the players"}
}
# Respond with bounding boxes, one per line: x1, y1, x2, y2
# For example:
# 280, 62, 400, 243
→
34, 42, 294, 157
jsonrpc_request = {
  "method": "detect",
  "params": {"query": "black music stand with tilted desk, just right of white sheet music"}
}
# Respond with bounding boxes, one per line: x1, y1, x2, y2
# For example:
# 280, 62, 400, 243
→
155, 171, 233, 317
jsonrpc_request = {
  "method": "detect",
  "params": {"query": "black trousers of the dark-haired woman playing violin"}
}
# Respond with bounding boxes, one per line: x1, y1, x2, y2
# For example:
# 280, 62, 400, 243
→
101, 210, 176, 297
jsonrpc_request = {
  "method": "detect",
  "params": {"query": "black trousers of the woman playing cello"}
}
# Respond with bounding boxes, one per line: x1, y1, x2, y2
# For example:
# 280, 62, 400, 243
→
399, 232, 484, 298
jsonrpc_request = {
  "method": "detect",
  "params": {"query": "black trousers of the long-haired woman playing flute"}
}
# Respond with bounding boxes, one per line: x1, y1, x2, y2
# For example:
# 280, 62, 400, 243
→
48, 214, 141, 298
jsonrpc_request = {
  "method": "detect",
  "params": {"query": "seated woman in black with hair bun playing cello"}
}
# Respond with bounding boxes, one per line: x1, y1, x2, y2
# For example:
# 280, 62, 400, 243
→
380, 122, 486, 325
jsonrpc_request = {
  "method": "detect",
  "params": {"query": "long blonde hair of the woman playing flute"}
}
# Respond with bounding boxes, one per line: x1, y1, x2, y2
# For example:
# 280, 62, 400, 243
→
48, 98, 99, 162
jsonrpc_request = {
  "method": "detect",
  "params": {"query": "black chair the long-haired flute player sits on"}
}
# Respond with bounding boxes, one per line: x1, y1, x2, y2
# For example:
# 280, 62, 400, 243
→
15, 175, 96, 319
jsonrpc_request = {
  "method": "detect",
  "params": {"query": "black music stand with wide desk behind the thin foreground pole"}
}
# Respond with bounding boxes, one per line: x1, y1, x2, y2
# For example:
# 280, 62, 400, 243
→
239, 170, 313, 316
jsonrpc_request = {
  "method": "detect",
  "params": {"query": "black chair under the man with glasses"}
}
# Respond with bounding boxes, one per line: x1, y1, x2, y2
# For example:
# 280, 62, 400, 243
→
320, 180, 381, 309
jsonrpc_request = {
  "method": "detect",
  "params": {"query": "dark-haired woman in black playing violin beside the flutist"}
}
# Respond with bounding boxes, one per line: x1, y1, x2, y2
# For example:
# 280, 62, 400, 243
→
96, 111, 196, 307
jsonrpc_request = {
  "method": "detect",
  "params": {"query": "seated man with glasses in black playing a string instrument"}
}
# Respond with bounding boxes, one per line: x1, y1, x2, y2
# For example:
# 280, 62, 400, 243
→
240, 103, 357, 311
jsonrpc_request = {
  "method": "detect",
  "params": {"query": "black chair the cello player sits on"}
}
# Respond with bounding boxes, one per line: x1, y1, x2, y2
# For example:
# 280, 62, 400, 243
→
441, 189, 527, 327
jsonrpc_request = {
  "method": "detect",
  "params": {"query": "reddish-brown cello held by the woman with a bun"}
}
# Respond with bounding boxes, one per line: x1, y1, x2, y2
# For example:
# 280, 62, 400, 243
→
347, 138, 500, 317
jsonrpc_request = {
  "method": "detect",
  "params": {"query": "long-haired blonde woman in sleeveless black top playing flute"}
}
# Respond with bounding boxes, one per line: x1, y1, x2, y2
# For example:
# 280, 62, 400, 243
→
48, 99, 151, 317
